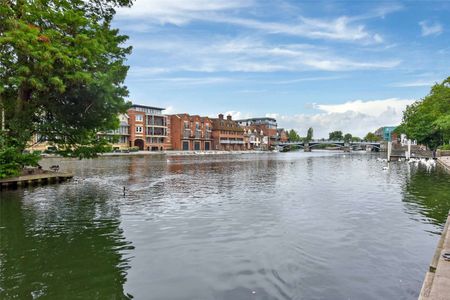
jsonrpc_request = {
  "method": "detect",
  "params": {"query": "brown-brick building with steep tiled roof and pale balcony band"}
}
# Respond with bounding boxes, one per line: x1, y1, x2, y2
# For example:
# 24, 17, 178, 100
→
212, 114, 245, 151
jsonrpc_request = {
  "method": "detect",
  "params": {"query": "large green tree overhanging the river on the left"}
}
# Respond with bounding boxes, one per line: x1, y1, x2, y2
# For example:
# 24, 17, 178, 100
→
0, 0, 131, 176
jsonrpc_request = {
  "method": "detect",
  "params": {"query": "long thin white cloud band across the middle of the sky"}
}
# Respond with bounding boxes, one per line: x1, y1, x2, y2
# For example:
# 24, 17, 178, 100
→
130, 36, 401, 77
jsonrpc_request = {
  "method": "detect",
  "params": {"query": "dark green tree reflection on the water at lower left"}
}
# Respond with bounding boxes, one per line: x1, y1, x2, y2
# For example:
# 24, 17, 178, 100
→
0, 186, 132, 299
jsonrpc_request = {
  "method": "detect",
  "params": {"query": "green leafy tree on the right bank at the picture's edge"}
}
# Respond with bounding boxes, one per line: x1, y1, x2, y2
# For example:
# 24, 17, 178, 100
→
396, 77, 450, 149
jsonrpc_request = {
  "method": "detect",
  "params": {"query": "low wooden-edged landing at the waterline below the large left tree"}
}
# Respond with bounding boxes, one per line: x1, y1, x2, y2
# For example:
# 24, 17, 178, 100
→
0, 172, 73, 190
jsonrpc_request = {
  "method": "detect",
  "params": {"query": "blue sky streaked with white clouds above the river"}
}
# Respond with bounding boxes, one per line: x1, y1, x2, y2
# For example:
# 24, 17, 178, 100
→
113, 0, 450, 138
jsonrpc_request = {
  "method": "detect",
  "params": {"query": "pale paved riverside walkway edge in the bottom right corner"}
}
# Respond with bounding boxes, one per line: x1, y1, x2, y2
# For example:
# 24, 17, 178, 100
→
419, 213, 450, 300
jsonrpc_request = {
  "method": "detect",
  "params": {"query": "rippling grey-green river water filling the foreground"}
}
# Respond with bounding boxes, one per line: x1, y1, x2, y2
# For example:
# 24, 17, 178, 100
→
0, 151, 450, 299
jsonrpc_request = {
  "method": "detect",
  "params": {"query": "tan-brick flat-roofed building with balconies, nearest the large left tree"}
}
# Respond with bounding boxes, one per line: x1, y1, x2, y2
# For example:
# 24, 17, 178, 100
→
127, 104, 168, 151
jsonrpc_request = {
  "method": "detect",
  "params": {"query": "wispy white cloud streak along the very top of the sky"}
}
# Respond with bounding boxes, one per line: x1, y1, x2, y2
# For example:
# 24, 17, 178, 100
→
117, 0, 392, 44
